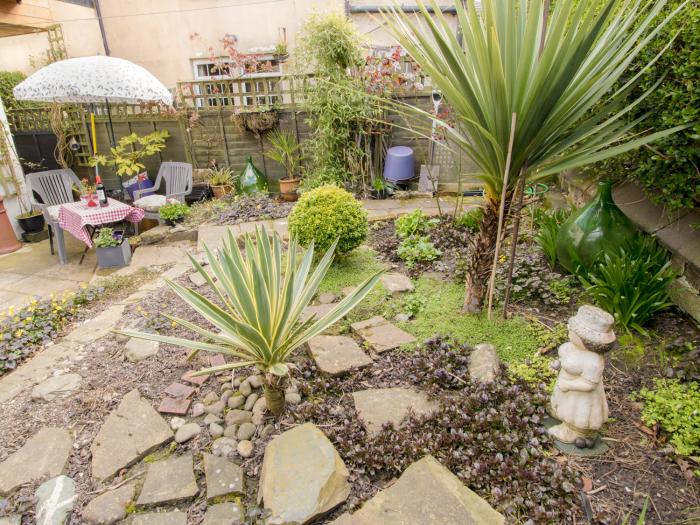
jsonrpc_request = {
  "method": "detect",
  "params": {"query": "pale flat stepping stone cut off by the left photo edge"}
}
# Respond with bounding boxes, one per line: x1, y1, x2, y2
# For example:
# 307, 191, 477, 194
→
0, 427, 73, 496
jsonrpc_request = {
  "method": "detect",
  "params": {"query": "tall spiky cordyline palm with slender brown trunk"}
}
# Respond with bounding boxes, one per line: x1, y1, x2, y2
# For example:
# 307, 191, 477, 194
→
384, 0, 687, 311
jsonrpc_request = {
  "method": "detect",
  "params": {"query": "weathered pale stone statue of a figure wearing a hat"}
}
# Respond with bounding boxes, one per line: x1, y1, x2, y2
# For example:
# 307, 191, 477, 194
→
549, 305, 615, 448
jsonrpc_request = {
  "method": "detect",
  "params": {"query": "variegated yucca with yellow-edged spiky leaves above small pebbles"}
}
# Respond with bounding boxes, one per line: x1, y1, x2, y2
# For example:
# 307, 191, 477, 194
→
120, 228, 382, 415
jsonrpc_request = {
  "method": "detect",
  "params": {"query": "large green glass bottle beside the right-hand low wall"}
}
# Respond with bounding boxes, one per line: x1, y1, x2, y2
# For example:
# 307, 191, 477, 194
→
557, 182, 637, 273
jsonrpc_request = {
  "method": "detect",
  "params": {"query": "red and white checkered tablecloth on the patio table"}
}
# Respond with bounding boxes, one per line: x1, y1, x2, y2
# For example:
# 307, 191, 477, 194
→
56, 198, 145, 248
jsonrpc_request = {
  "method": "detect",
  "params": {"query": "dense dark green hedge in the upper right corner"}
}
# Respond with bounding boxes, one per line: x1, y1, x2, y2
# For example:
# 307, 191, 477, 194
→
591, 0, 700, 210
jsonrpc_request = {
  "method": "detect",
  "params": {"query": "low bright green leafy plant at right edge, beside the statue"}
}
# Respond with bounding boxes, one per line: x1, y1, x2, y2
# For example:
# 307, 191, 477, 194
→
638, 379, 700, 456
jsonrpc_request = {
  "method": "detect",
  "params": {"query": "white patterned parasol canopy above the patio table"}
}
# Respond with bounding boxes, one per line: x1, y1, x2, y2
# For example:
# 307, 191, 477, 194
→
12, 56, 173, 105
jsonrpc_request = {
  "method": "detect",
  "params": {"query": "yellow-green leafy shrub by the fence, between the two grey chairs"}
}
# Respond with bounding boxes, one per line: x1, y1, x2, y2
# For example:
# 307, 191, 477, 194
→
90, 130, 170, 177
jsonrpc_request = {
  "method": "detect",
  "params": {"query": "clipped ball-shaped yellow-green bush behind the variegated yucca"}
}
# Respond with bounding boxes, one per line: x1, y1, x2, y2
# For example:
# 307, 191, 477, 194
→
289, 186, 369, 253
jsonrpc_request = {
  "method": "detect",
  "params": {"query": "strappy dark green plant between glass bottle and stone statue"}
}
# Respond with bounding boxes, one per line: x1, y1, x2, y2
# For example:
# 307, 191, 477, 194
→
579, 235, 675, 334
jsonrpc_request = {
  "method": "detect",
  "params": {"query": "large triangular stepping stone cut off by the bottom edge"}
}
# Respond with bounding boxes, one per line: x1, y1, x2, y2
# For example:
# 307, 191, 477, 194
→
331, 456, 505, 525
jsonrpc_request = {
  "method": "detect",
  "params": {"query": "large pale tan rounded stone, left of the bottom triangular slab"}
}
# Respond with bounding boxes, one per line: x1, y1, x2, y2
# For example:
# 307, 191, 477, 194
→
258, 423, 350, 525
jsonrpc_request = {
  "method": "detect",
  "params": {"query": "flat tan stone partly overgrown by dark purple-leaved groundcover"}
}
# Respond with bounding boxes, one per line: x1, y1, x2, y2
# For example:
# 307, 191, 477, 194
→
352, 387, 439, 436
